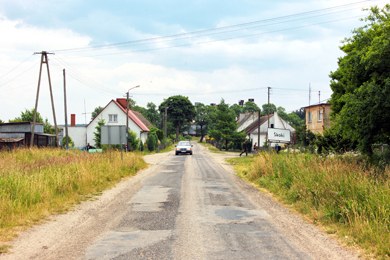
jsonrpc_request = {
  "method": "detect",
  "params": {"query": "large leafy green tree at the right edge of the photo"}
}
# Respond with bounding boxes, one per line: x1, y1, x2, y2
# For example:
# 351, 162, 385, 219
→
330, 4, 390, 155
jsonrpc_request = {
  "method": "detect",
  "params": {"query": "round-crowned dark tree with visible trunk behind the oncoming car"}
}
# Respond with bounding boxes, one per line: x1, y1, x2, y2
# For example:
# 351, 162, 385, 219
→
159, 95, 195, 141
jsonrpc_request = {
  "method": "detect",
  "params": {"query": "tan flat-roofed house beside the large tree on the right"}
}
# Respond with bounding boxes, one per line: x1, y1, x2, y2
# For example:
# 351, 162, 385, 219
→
304, 103, 331, 134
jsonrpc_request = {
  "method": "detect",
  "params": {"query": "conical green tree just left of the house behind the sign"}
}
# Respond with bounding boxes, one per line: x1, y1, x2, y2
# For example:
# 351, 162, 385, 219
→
209, 99, 245, 150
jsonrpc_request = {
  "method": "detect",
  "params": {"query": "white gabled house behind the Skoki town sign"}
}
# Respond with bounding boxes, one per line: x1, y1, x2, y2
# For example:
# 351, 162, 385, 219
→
237, 112, 295, 146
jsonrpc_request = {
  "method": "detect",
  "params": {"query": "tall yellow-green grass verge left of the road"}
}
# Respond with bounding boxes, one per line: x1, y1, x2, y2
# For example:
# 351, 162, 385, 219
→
0, 149, 146, 250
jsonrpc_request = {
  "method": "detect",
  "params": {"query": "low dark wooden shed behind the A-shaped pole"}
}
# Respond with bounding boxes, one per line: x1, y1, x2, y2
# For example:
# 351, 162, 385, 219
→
0, 122, 56, 149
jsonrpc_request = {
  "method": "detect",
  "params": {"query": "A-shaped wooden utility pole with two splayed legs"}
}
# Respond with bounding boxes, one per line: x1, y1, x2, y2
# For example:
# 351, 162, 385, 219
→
30, 51, 58, 147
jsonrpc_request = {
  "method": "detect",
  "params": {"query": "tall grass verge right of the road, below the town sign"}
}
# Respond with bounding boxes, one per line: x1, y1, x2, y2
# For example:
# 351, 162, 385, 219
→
229, 153, 390, 258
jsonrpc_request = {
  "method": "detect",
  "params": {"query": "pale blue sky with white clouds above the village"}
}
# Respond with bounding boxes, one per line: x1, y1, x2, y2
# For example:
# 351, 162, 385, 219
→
0, 0, 386, 124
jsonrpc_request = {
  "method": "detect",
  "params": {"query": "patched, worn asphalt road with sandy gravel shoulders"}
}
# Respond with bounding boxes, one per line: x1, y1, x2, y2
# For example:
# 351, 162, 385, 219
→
0, 144, 357, 259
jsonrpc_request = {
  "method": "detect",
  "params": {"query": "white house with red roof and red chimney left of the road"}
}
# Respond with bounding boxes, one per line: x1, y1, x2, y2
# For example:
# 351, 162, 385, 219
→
60, 98, 151, 148
